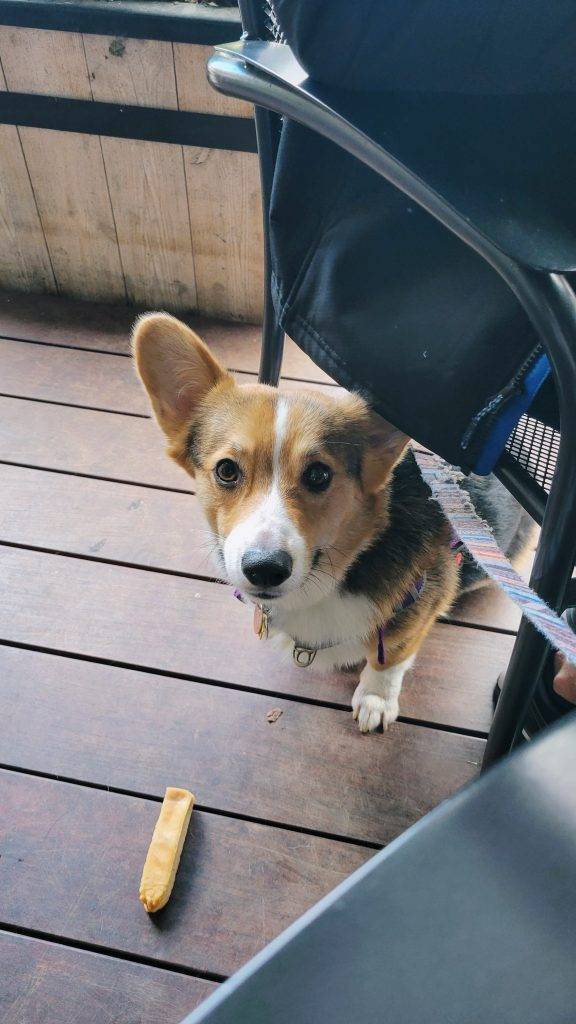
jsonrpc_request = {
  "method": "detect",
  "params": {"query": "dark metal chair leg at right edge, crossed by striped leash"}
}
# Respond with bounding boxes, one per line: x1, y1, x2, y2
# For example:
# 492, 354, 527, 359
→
483, 275, 576, 768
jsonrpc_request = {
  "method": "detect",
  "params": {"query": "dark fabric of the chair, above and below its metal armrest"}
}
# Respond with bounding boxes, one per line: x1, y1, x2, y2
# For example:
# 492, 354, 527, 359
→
255, 0, 576, 473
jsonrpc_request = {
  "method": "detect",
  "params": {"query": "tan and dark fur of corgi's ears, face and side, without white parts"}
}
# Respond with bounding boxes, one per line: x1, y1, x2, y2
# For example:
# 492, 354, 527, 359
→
134, 313, 458, 725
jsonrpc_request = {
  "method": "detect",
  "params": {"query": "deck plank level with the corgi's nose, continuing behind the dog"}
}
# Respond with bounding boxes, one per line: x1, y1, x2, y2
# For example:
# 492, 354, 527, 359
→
0, 456, 519, 634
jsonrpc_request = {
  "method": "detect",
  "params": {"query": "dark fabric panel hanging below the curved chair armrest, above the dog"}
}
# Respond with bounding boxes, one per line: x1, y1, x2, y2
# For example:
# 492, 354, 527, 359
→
271, 122, 545, 472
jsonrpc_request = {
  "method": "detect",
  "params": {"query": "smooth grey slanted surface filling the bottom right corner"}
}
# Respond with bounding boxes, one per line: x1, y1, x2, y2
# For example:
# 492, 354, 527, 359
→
179, 714, 576, 1024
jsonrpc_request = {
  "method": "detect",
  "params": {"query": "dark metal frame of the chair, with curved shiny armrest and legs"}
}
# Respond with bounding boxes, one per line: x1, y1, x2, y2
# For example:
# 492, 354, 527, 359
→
207, 0, 576, 767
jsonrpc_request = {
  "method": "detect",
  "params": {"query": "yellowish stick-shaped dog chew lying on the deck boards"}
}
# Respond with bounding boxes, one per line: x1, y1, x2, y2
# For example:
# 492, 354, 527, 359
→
139, 786, 195, 913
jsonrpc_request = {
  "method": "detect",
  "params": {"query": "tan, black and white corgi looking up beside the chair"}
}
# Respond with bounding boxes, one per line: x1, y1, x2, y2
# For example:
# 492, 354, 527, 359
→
133, 313, 532, 732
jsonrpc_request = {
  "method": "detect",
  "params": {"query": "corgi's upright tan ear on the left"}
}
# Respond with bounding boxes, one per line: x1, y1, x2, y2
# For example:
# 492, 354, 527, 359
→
132, 313, 230, 440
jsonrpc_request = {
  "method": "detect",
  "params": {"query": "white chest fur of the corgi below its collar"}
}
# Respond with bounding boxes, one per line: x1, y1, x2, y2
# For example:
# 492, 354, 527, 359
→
270, 592, 375, 669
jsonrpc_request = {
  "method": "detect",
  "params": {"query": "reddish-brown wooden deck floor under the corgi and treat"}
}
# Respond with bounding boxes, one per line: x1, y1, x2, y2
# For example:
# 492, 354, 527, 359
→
0, 295, 518, 1024
